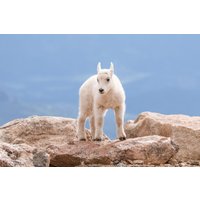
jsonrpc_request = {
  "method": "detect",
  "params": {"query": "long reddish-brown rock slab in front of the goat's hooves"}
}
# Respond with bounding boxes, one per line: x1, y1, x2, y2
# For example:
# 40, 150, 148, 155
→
48, 136, 178, 167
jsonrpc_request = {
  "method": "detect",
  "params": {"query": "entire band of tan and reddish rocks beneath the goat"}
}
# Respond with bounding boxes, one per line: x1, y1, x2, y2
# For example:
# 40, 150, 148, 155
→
0, 113, 200, 167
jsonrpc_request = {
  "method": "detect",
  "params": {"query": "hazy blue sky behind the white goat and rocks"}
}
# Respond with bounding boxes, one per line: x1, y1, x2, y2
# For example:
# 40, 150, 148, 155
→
0, 35, 200, 137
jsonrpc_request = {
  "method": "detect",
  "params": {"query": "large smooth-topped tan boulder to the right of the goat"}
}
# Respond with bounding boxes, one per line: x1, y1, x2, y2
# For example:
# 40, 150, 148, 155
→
125, 112, 200, 162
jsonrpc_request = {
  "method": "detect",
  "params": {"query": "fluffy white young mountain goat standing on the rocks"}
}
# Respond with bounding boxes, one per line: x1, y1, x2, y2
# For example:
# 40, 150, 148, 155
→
77, 63, 126, 140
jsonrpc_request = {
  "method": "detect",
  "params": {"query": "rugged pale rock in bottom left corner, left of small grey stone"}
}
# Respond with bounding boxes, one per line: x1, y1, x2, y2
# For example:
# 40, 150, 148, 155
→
0, 143, 34, 167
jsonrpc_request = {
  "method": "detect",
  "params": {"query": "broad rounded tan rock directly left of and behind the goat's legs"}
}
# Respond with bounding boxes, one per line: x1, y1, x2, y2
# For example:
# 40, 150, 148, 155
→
0, 116, 91, 149
